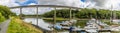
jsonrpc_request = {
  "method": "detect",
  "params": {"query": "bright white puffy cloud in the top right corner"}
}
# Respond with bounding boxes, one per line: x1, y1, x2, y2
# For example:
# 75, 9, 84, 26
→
104, 0, 120, 10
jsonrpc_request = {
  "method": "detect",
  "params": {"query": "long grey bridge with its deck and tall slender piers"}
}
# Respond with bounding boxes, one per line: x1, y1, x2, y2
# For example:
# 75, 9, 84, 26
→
9, 5, 81, 25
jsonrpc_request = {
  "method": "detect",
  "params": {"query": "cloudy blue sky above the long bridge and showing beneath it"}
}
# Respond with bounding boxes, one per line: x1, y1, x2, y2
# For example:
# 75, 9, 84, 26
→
0, 0, 120, 13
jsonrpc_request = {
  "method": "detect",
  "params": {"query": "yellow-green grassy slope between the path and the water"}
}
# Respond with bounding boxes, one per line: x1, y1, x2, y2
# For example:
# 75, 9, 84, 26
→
7, 18, 43, 33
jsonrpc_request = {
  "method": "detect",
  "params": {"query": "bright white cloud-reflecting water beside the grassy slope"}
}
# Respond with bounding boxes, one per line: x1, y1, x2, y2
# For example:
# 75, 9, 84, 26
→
24, 18, 51, 30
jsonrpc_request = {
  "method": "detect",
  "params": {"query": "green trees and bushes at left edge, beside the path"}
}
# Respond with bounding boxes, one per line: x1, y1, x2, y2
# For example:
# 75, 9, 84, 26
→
0, 5, 16, 22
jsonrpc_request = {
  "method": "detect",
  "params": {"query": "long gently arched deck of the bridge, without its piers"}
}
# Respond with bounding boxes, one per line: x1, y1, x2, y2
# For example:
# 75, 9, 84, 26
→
9, 5, 81, 9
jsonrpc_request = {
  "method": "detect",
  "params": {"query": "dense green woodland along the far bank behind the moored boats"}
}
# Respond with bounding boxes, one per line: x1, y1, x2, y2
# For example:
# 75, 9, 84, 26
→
42, 8, 120, 19
